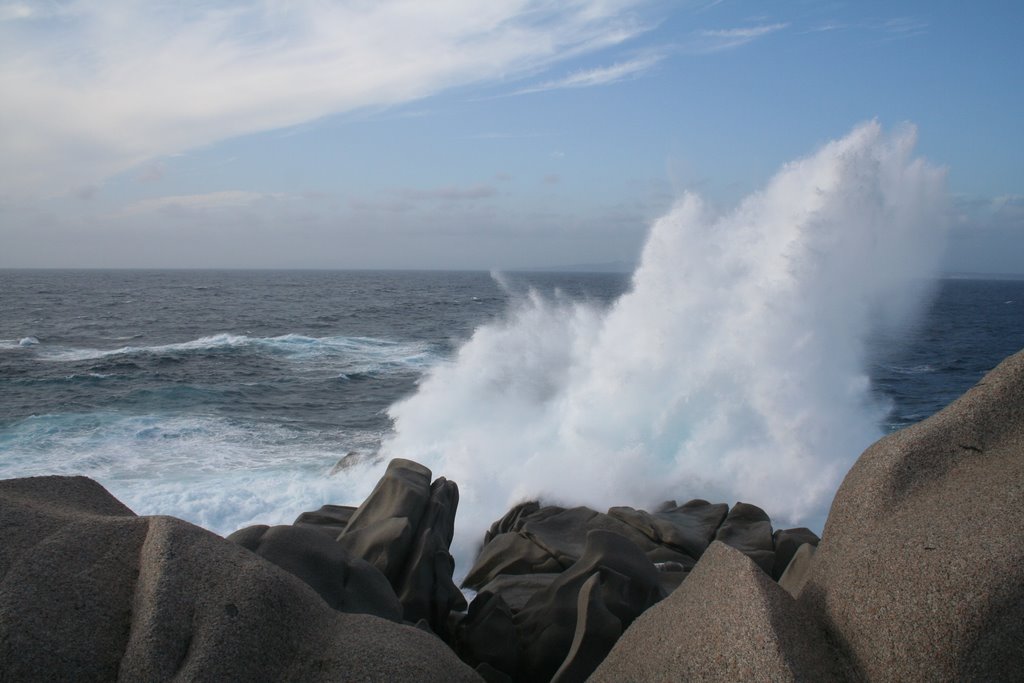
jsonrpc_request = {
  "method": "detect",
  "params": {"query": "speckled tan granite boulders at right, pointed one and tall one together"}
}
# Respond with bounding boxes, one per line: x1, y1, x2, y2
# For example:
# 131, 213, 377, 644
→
591, 351, 1024, 681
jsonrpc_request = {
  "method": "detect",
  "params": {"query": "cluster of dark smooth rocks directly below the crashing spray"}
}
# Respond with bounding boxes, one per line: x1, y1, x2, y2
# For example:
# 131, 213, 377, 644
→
455, 500, 817, 683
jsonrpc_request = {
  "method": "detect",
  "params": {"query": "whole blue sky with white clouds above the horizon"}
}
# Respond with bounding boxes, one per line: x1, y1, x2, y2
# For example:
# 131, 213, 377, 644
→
0, 0, 1024, 273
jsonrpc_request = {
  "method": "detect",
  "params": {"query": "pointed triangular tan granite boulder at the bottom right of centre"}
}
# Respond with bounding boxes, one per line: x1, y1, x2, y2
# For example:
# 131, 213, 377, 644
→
589, 543, 842, 683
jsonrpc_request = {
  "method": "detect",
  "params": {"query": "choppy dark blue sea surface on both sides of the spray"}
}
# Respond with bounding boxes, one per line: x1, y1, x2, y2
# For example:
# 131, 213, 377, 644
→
0, 270, 1024, 533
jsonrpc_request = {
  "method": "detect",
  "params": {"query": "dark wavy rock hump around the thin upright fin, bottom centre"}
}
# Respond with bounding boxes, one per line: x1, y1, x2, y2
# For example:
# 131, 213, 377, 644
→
515, 528, 665, 681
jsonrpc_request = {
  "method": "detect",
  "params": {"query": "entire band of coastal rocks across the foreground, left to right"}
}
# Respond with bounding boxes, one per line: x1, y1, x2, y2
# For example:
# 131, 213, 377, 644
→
0, 352, 1024, 683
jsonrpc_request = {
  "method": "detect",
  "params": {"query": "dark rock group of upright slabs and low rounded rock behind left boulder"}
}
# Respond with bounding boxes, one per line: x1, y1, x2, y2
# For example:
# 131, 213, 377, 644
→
234, 458, 466, 637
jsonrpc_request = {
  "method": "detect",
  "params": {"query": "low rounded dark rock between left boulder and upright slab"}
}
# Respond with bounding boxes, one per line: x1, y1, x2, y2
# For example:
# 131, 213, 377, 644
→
227, 525, 403, 623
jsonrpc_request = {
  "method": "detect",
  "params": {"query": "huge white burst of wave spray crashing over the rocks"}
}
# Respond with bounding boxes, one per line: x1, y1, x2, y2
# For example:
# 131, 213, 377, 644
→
376, 122, 949, 563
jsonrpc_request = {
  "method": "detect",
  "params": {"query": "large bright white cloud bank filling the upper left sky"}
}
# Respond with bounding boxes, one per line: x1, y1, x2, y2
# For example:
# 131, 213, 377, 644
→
0, 0, 649, 196
